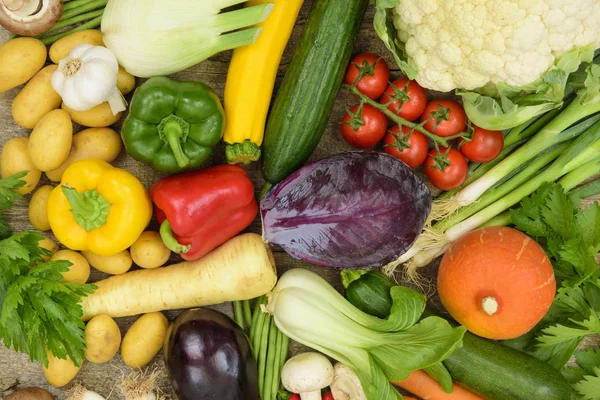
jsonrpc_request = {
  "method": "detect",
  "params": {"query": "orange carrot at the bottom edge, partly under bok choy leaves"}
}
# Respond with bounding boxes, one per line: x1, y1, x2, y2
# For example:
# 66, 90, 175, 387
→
392, 371, 484, 400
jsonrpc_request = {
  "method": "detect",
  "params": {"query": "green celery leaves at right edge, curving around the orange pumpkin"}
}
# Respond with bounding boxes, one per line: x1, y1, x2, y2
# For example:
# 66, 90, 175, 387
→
505, 183, 600, 368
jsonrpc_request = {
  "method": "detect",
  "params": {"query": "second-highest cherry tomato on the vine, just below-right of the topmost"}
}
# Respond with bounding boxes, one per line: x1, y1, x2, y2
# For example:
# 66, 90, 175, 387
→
379, 78, 427, 121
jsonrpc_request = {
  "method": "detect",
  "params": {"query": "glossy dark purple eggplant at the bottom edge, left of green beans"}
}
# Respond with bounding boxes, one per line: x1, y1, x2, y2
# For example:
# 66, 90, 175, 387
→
165, 308, 259, 400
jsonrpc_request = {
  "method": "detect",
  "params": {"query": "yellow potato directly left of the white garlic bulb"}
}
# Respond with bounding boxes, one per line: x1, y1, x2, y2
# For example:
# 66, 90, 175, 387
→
12, 65, 62, 129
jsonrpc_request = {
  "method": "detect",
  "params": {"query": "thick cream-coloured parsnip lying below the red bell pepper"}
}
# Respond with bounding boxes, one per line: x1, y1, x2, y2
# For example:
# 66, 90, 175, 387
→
82, 233, 277, 321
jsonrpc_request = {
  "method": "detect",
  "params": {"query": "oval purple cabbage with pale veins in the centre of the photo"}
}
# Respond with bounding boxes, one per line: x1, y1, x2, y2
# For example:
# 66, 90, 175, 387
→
260, 152, 431, 268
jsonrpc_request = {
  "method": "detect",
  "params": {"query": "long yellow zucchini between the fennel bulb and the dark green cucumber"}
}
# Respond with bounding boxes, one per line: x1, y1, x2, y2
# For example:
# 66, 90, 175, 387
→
223, 0, 304, 164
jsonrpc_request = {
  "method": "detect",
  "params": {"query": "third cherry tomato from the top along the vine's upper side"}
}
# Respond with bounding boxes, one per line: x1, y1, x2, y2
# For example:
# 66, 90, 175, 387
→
421, 99, 467, 137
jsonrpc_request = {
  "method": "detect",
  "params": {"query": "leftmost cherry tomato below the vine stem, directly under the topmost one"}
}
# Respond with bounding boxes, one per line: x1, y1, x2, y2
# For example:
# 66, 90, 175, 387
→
341, 104, 387, 149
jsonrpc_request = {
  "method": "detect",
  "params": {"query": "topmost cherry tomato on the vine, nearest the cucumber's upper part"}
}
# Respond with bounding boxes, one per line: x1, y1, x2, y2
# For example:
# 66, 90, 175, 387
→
344, 53, 390, 100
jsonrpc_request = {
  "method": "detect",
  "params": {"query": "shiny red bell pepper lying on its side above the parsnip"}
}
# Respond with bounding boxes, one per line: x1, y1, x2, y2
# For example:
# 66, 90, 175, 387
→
150, 165, 258, 260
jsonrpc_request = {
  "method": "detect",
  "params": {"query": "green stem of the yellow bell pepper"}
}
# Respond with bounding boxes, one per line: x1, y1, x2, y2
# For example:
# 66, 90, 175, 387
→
62, 185, 110, 232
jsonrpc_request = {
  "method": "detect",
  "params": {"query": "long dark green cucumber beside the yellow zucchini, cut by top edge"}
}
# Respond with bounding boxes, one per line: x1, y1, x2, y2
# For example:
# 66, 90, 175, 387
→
262, 0, 369, 191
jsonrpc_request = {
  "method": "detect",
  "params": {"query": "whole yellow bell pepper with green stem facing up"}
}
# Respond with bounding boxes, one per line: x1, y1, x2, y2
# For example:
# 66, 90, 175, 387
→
47, 160, 152, 256
